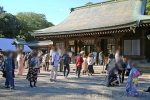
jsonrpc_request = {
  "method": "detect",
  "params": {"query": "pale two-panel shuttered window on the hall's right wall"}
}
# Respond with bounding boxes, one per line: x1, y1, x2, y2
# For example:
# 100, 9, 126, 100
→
124, 39, 140, 55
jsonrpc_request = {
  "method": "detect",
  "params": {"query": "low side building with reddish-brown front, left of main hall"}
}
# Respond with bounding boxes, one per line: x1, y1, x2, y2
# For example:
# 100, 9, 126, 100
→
27, 40, 53, 52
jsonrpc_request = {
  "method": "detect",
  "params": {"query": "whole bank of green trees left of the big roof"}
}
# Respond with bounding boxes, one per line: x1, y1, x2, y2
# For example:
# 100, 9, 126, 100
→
0, 6, 53, 41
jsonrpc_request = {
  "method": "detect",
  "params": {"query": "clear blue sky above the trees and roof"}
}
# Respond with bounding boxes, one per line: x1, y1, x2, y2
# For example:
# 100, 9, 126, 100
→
0, 0, 106, 25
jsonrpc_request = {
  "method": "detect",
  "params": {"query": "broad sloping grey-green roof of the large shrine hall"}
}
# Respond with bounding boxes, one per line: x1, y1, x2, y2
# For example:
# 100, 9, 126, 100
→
32, 0, 150, 36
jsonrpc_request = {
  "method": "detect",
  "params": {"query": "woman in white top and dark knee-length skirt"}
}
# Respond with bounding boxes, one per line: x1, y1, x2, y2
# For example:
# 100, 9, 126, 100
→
87, 53, 94, 75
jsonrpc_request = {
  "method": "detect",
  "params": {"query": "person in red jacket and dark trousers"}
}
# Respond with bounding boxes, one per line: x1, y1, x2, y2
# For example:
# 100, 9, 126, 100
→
76, 54, 83, 78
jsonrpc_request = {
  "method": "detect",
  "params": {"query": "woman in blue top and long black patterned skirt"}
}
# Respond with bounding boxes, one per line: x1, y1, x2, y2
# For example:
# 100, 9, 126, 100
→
27, 51, 40, 87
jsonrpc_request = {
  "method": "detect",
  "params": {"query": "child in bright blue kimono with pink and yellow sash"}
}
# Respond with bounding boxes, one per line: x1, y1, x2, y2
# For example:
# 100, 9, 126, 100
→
126, 62, 140, 96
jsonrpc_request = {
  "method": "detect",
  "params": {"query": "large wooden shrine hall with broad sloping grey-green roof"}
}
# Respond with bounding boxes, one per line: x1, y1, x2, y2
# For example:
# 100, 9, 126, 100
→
32, 0, 150, 59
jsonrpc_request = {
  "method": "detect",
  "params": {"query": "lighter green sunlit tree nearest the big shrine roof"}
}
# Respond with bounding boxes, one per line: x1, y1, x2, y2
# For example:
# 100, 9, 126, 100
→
16, 12, 53, 41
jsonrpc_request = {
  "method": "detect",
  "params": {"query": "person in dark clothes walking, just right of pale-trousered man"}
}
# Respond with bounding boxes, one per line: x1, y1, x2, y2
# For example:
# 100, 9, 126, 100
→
62, 49, 70, 78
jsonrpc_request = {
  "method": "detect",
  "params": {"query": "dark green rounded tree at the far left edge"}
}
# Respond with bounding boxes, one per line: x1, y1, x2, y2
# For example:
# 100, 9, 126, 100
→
0, 13, 20, 38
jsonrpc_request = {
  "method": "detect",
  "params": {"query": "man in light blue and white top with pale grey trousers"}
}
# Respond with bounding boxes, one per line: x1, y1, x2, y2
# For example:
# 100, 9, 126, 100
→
50, 48, 60, 82
